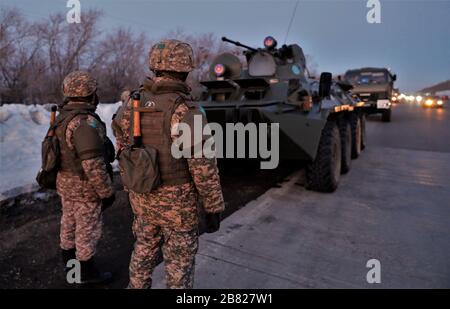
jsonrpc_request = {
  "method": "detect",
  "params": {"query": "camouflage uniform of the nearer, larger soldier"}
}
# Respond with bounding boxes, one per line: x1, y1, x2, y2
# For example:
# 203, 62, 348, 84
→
113, 42, 224, 288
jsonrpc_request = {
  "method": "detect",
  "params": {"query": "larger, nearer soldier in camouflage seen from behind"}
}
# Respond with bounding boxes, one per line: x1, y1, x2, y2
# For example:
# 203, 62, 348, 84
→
112, 40, 224, 288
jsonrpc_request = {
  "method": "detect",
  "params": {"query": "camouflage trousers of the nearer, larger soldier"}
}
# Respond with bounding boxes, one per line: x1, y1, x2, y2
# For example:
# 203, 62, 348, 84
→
128, 216, 198, 289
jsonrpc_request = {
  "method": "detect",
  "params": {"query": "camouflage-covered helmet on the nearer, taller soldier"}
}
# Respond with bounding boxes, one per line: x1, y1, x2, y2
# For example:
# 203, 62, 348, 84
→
149, 40, 194, 73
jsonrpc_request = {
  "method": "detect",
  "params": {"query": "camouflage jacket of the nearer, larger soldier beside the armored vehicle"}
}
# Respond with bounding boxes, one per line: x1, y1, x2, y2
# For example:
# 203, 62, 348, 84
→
112, 78, 225, 229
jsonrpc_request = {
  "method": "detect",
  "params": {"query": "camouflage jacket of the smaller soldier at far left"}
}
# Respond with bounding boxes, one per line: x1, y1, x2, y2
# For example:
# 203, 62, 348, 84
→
56, 102, 113, 201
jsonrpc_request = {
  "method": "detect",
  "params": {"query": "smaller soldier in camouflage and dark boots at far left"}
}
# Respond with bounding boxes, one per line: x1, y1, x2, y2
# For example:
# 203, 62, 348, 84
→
55, 71, 115, 283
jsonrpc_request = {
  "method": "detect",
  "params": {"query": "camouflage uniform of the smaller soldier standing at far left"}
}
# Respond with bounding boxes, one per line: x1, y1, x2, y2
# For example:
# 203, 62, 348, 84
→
56, 72, 114, 261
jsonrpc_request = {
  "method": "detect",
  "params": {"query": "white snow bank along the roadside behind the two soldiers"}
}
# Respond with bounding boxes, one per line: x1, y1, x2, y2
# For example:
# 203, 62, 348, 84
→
0, 102, 121, 201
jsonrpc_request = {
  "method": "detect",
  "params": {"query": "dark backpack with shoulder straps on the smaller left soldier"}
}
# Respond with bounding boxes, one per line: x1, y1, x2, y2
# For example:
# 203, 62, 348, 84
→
36, 110, 115, 189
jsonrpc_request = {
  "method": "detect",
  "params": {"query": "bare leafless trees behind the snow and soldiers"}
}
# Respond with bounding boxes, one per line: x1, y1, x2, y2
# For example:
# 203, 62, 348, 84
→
0, 8, 241, 104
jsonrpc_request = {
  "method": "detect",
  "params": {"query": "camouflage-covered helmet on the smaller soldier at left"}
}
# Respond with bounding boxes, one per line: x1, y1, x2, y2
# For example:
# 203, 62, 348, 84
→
62, 71, 97, 98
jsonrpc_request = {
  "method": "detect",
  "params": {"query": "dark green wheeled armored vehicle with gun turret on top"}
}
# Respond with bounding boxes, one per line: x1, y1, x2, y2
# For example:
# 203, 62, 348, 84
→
198, 36, 364, 192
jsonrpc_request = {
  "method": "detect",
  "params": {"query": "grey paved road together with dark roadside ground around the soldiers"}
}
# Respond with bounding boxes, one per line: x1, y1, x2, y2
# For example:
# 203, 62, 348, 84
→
0, 105, 450, 288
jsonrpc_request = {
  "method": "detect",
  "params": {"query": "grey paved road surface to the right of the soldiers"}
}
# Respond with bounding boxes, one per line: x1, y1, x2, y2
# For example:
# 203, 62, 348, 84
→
155, 102, 450, 288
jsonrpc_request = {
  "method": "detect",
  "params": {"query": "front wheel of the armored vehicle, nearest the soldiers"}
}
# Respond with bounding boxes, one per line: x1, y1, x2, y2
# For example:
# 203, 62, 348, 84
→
305, 121, 341, 192
